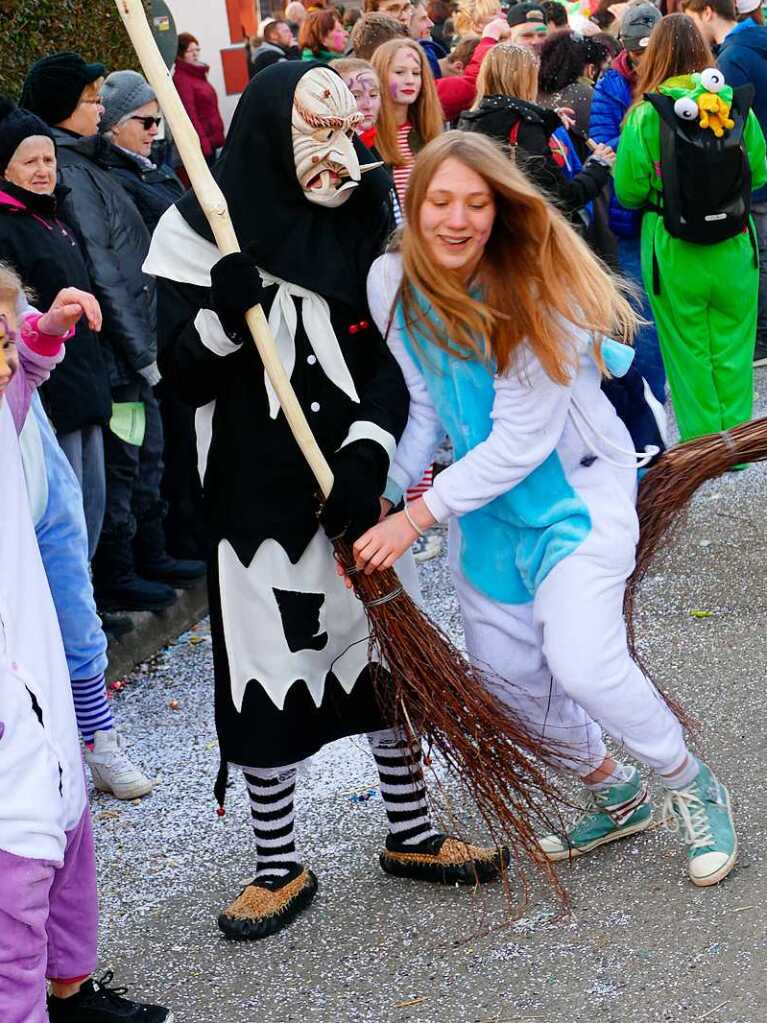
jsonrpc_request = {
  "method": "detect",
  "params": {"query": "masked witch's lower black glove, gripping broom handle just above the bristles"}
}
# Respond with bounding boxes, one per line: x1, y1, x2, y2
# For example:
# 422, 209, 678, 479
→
320, 441, 389, 543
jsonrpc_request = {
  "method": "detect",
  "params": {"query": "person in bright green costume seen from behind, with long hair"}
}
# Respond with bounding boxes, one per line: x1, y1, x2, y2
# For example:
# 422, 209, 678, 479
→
615, 14, 767, 440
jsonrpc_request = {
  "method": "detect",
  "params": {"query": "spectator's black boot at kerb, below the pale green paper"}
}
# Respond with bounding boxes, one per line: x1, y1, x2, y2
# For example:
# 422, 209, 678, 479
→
93, 536, 176, 611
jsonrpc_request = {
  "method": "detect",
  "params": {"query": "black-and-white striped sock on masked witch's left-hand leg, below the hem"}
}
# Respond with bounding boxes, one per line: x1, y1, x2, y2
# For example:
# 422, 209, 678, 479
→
243, 764, 299, 881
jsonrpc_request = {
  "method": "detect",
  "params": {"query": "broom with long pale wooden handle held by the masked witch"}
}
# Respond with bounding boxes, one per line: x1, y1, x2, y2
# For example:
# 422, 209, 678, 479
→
116, 0, 567, 903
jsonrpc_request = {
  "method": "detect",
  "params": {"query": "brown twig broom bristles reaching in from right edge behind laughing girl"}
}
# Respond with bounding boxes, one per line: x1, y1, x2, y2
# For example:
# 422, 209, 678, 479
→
624, 418, 767, 656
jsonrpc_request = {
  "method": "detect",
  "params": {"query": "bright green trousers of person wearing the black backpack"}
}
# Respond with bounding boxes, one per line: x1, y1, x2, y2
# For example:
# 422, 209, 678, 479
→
642, 213, 759, 441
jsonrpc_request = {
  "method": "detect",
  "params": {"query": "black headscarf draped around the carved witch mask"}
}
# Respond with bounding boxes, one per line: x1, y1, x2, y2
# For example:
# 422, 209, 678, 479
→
177, 60, 393, 307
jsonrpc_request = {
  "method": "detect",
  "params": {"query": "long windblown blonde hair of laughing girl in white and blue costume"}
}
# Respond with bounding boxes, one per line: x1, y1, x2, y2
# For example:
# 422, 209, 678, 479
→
401, 131, 637, 384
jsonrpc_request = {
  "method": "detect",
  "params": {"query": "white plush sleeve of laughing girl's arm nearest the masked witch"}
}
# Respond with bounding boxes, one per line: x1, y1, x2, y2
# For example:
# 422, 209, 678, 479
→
367, 253, 446, 503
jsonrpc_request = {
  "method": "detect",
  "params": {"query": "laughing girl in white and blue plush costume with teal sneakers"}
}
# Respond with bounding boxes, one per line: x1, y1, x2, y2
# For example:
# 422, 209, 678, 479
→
364, 132, 736, 886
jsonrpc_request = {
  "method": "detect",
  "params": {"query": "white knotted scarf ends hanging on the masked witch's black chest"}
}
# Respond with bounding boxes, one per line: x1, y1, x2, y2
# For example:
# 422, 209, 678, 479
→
259, 268, 360, 419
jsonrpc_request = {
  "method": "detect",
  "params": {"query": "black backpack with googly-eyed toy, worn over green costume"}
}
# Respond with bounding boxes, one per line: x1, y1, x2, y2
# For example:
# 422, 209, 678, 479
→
644, 85, 754, 246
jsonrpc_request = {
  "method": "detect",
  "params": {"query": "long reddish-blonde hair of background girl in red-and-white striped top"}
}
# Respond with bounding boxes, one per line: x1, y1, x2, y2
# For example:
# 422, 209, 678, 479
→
371, 36, 444, 167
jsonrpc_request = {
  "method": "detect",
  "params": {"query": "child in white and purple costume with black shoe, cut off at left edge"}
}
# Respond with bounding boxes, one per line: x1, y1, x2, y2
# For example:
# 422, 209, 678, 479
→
0, 268, 171, 1023
